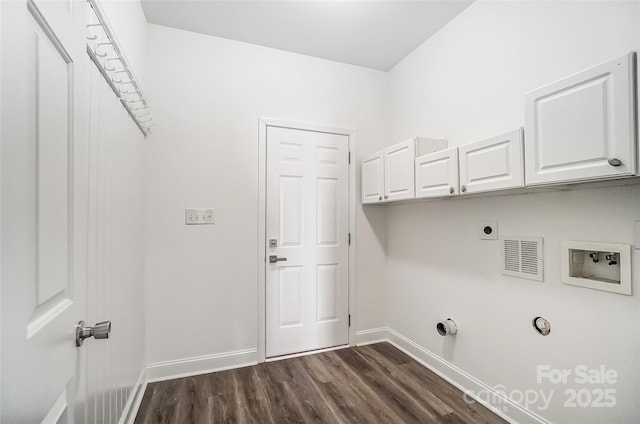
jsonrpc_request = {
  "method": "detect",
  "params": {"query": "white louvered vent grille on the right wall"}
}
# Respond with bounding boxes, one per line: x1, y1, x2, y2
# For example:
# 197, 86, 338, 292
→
502, 236, 544, 281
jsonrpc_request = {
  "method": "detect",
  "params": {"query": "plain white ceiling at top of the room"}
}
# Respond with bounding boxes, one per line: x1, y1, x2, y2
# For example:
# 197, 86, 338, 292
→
142, 0, 472, 71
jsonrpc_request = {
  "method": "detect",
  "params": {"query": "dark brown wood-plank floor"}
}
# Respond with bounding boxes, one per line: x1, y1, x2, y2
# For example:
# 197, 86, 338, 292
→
135, 343, 506, 424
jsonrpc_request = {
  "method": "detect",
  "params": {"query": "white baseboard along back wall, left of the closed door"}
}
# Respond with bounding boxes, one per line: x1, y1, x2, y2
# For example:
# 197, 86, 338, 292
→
145, 349, 258, 383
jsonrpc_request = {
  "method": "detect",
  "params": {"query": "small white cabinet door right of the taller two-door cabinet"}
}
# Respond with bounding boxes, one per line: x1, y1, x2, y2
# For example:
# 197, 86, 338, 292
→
415, 147, 458, 198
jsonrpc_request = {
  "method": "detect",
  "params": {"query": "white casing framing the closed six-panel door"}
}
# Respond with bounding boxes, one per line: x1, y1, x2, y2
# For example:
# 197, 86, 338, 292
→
257, 117, 357, 363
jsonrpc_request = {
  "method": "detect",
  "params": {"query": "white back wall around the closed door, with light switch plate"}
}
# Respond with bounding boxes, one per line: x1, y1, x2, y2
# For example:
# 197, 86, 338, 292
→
145, 25, 388, 363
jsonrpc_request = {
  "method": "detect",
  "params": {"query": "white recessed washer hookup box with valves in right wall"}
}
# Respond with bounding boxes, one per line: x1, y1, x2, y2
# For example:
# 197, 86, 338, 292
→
560, 241, 631, 295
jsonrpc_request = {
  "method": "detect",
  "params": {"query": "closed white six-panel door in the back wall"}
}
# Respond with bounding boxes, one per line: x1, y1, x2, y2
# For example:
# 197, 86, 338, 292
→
266, 127, 349, 357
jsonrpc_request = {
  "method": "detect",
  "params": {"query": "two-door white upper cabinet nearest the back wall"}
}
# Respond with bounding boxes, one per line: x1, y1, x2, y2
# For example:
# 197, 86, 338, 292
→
361, 137, 447, 203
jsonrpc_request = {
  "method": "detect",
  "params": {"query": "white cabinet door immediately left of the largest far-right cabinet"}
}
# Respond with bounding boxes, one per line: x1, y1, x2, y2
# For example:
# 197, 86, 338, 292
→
458, 129, 524, 193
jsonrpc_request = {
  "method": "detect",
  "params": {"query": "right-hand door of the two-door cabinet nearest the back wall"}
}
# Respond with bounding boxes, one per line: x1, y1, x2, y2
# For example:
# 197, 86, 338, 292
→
384, 139, 415, 201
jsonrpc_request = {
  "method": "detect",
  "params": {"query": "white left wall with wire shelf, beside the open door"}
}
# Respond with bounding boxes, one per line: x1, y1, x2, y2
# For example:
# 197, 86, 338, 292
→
86, 0, 149, 424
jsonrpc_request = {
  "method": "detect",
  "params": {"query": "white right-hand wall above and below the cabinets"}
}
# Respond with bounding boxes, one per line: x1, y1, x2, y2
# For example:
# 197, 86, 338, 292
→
384, 1, 640, 423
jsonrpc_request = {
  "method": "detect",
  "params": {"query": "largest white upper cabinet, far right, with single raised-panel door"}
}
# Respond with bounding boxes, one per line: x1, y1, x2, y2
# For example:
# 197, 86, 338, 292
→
525, 53, 636, 185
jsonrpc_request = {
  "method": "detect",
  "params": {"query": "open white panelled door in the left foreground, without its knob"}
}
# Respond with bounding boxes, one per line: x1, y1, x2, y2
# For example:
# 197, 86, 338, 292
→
0, 0, 88, 423
